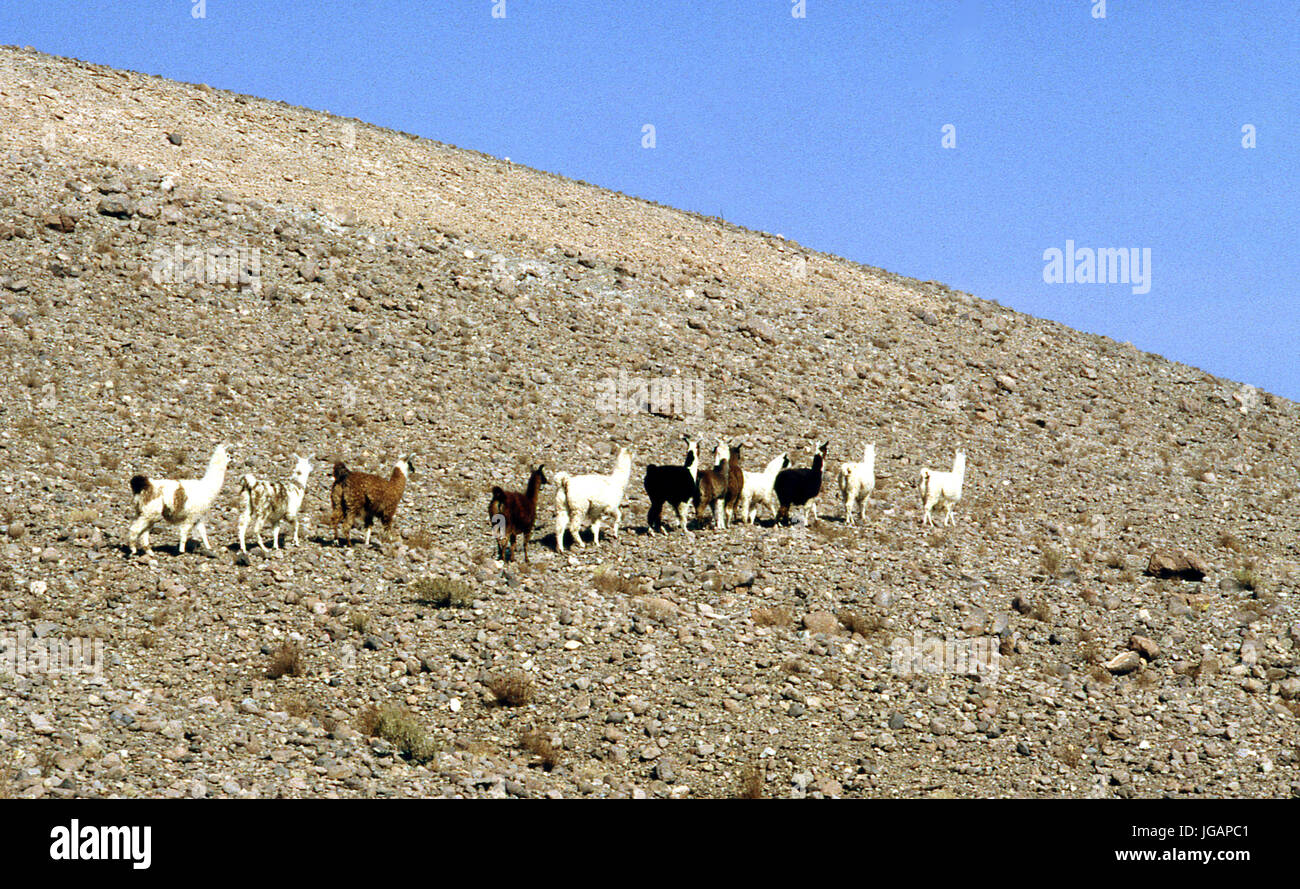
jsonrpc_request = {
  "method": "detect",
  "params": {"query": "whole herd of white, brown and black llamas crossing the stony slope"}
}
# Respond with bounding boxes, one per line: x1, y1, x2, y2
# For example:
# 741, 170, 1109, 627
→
127, 435, 966, 561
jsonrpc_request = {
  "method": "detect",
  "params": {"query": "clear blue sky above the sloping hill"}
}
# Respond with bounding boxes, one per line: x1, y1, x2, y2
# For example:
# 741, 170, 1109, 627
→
0, 0, 1300, 399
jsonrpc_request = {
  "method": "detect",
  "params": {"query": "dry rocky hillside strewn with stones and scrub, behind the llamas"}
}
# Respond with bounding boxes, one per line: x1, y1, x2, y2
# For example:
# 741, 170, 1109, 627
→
0, 48, 1300, 797
